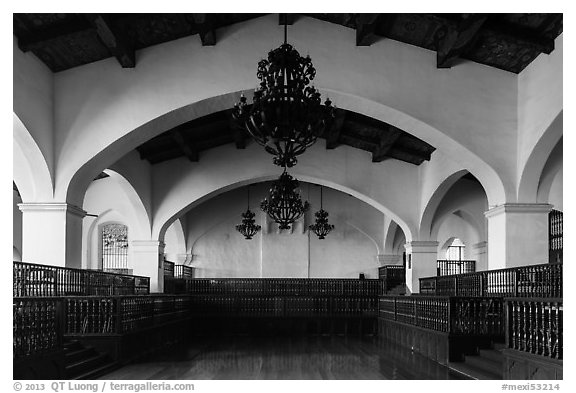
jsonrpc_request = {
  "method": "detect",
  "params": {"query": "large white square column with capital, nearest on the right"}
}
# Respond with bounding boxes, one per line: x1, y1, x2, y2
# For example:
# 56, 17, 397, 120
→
484, 203, 552, 270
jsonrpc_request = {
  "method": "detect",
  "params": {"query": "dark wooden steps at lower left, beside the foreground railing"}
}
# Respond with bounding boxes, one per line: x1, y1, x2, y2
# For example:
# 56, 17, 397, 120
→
64, 340, 119, 379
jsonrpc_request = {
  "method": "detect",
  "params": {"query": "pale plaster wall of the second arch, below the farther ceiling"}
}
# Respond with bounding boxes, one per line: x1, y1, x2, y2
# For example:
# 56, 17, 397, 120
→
152, 143, 418, 239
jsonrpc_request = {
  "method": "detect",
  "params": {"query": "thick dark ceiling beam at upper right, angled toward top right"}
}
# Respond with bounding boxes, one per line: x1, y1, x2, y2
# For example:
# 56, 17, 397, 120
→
436, 14, 488, 68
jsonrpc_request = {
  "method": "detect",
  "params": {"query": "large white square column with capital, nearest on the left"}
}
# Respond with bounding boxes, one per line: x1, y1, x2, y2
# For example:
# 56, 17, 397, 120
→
18, 202, 86, 268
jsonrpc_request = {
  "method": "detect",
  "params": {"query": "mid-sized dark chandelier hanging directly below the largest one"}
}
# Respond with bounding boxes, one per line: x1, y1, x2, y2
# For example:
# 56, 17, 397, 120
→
260, 168, 310, 229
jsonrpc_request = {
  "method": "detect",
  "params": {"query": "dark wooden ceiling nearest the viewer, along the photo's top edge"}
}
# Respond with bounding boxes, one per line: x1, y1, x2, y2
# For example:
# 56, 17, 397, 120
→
13, 14, 563, 73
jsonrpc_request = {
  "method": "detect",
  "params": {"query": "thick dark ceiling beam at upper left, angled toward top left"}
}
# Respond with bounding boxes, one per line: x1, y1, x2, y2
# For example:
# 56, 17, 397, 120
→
85, 14, 136, 68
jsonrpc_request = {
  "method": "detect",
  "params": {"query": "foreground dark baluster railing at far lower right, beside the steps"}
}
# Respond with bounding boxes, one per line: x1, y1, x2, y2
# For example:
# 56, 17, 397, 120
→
506, 298, 563, 360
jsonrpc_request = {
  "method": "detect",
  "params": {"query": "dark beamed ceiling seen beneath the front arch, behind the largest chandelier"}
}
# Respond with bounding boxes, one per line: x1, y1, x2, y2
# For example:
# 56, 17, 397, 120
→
136, 109, 435, 165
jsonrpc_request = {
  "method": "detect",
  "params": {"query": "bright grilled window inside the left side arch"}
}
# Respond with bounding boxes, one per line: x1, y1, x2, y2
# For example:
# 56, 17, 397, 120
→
101, 223, 130, 273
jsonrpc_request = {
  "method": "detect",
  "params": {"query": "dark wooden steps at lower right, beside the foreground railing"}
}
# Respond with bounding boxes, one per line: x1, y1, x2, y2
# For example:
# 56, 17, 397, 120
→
448, 343, 504, 380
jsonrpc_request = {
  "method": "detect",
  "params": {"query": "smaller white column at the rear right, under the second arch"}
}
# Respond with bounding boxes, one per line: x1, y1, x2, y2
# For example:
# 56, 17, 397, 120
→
404, 241, 438, 293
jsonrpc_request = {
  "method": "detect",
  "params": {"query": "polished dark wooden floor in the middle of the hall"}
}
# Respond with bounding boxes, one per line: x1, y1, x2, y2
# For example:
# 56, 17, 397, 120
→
102, 336, 463, 380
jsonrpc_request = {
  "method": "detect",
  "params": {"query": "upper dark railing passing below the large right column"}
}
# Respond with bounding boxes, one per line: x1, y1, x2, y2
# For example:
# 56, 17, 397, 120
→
420, 263, 562, 297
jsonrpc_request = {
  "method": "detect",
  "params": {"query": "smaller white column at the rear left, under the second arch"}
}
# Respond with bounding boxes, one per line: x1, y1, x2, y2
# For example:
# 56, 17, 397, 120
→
130, 240, 164, 293
